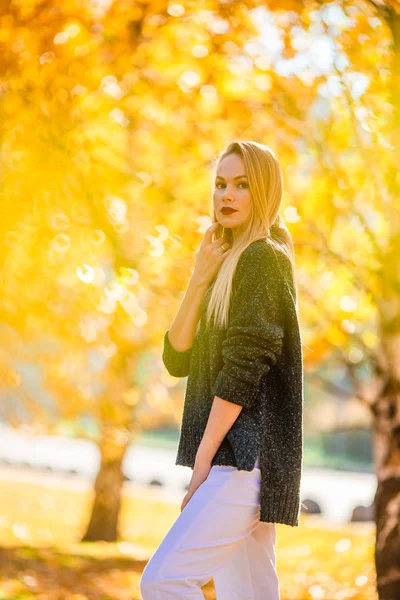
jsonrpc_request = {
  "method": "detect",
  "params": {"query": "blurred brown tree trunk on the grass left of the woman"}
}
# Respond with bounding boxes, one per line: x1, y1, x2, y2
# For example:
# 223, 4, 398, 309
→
81, 427, 127, 542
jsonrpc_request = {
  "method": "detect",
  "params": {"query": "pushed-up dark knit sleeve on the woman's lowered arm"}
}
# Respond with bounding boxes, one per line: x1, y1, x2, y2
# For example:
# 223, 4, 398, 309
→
213, 245, 284, 408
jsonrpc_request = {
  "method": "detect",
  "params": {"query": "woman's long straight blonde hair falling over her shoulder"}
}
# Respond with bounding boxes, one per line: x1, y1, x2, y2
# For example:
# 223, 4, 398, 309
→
206, 140, 298, 328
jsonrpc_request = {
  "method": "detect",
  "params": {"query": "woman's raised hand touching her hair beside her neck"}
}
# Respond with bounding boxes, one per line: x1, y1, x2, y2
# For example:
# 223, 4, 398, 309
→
193, 222, 231, 285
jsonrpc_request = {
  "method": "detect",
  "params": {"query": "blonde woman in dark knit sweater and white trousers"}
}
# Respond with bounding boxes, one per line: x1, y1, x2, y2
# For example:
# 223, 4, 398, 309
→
140, 141, 303, 600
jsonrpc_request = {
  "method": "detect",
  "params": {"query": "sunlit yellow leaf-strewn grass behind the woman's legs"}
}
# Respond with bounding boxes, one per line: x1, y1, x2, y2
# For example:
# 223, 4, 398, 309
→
0, 478, 377, 600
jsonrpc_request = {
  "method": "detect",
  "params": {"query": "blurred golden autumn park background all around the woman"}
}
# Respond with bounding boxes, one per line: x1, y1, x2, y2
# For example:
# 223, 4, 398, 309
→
0, 0, 400, 600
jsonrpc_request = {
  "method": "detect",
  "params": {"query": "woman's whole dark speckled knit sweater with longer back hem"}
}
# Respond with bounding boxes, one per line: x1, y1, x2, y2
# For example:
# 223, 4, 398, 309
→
163, 239, 304, 526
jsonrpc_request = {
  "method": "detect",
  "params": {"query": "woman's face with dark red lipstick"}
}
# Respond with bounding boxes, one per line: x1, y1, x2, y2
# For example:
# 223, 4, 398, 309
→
213, 154, 252, 235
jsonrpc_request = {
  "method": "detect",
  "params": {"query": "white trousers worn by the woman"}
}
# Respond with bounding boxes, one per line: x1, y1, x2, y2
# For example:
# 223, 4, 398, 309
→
140, 465, 280, 600
